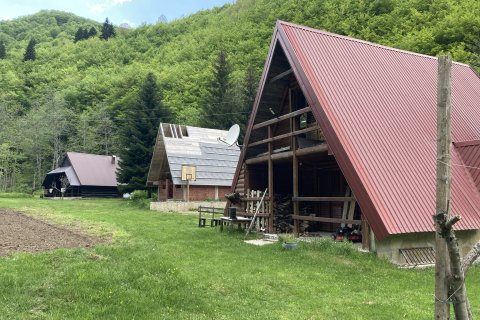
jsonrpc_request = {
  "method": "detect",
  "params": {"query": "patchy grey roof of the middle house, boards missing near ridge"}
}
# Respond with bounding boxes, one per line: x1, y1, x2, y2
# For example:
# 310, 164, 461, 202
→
147, 123, 240, 186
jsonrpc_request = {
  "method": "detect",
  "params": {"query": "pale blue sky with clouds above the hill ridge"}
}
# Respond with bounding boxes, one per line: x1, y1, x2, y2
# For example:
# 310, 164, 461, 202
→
0, 0, 234, 27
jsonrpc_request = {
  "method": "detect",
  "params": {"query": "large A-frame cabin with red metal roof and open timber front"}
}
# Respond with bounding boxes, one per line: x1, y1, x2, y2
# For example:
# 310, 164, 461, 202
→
229, 21, 480, 263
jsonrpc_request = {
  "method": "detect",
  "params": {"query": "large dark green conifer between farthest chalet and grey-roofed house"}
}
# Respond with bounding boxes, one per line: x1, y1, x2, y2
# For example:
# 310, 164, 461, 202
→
117, 73, 171, 192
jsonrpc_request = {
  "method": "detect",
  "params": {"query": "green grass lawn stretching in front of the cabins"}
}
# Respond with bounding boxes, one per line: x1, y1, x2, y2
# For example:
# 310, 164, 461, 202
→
0, 198, 480, 320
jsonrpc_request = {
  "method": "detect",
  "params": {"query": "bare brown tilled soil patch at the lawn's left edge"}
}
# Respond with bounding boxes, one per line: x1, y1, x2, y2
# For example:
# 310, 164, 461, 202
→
0, 209, 101, 256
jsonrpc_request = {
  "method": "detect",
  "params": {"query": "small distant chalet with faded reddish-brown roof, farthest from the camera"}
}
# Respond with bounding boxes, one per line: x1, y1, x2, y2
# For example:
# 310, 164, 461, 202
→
42, 152, 119, 198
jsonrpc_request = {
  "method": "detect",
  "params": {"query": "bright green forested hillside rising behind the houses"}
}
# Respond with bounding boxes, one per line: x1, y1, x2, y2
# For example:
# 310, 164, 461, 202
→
0, 0, 480, 191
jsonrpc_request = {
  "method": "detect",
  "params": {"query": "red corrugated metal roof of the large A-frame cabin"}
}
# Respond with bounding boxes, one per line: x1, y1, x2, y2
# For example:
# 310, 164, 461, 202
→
277, 22, 480, 239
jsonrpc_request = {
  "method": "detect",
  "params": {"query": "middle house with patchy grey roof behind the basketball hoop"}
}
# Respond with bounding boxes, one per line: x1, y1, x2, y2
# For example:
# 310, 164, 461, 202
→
147, 123, 240, 201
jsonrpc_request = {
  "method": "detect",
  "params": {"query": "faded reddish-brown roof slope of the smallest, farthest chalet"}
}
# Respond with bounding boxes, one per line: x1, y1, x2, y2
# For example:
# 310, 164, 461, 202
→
64, 152, 118, 187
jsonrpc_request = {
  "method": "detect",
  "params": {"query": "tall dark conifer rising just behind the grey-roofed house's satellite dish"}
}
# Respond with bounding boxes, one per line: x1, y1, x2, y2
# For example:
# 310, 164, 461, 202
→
201, 50, 235, 129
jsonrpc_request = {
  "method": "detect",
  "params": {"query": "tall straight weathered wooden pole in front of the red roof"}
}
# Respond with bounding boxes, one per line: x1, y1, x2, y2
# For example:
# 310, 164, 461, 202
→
435, 56, 452, 320
